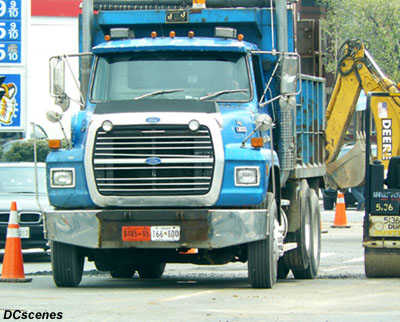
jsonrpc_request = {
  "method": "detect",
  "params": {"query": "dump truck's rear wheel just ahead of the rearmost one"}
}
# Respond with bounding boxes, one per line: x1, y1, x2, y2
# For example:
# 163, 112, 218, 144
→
285, 180, 312, 272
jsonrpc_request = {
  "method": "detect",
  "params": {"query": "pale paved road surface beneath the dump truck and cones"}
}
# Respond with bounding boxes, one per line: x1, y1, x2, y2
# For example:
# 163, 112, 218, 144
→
0, 210, 400, 322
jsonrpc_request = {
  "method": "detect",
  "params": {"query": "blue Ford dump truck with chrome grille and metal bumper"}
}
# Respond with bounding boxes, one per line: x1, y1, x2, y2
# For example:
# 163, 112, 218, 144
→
45, 0, 326, 288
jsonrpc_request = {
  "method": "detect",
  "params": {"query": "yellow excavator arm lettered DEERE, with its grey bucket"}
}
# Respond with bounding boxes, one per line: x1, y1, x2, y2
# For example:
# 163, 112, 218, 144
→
325, 41, 400, 189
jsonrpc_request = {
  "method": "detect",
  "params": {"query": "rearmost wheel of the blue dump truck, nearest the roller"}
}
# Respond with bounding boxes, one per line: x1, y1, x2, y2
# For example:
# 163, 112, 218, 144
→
293, 189, 321, 279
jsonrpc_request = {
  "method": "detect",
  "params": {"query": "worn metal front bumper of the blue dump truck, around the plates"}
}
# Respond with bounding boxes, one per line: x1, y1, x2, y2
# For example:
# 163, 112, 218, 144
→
45, 209, 269, 249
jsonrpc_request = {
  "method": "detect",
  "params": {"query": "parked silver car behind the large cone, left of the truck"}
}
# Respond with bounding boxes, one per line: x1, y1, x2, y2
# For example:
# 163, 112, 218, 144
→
0, 162, 51, 249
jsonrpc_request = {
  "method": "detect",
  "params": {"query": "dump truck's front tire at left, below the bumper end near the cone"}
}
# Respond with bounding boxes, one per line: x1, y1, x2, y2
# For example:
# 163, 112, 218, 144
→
51, 241, 84, 287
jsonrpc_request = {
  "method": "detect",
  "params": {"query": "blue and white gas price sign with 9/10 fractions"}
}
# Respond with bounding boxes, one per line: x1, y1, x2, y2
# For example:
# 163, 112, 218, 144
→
0, 0, 23, 65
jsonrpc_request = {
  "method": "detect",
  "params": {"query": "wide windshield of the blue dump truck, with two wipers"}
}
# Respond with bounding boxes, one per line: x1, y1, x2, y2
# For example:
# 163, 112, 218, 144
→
91, 52, 252, 102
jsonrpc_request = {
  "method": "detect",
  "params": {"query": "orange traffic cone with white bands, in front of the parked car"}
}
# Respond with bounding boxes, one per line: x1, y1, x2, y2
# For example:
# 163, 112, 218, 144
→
0, 201, 32, 282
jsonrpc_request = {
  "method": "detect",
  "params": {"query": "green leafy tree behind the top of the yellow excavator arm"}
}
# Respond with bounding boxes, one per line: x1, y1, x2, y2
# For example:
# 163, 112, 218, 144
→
318, 0, 400, 82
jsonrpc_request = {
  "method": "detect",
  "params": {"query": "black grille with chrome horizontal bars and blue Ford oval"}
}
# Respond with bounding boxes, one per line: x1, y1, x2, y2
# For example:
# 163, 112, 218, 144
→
93, 124, 214, 196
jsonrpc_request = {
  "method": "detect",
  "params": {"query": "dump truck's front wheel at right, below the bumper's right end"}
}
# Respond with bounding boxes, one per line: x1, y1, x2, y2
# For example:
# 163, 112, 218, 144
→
247, 193, 279, 288
